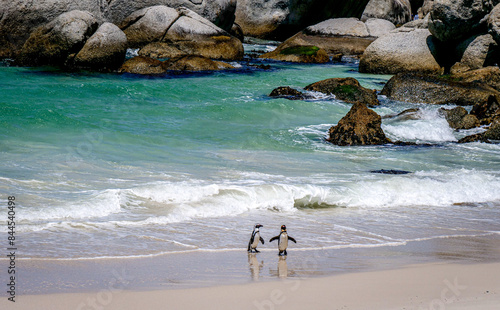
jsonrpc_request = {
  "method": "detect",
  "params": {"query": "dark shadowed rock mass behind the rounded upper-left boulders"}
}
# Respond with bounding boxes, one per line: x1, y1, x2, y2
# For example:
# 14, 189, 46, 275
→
0, 0, 236, 58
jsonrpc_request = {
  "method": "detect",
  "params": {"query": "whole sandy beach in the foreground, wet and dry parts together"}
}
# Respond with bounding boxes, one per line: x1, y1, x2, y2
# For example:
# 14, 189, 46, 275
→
0, 234, 500, 310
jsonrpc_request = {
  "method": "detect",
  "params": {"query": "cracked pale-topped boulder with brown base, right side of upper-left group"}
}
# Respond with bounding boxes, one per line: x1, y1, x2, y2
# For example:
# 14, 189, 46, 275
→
120, 6, 243, 59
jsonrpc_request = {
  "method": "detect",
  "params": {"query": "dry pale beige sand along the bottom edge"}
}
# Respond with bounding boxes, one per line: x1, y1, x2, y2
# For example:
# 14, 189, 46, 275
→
0, 263, 500, 310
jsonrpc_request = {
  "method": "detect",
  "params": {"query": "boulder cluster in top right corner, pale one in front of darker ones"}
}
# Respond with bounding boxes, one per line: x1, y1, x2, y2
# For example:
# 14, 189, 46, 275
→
359, 0, 500, 74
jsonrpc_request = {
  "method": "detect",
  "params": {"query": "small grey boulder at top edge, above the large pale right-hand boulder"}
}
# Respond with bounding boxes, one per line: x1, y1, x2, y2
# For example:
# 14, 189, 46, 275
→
361, 0, 412, 25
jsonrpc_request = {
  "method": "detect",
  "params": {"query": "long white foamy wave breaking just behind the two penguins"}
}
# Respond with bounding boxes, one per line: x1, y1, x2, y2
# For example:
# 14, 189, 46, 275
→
17, 169, 500, 230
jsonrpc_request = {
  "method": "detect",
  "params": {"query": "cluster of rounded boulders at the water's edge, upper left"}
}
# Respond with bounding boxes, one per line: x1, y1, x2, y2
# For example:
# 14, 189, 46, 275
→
0, 1, 243, 72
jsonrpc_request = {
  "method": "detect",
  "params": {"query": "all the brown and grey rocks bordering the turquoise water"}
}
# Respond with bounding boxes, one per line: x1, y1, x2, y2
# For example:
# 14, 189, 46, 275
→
0, 0, 500, 145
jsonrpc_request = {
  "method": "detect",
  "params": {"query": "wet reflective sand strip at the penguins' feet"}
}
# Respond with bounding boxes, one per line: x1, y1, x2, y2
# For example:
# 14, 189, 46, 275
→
0, 233, 500, 305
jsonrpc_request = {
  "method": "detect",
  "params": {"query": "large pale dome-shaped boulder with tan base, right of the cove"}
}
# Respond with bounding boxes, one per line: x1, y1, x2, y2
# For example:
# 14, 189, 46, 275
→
359, 27, 443, 74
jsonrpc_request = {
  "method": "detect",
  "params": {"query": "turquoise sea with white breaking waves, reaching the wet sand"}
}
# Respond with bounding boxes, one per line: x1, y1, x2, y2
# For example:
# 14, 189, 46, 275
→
0, 46, 500, 259
